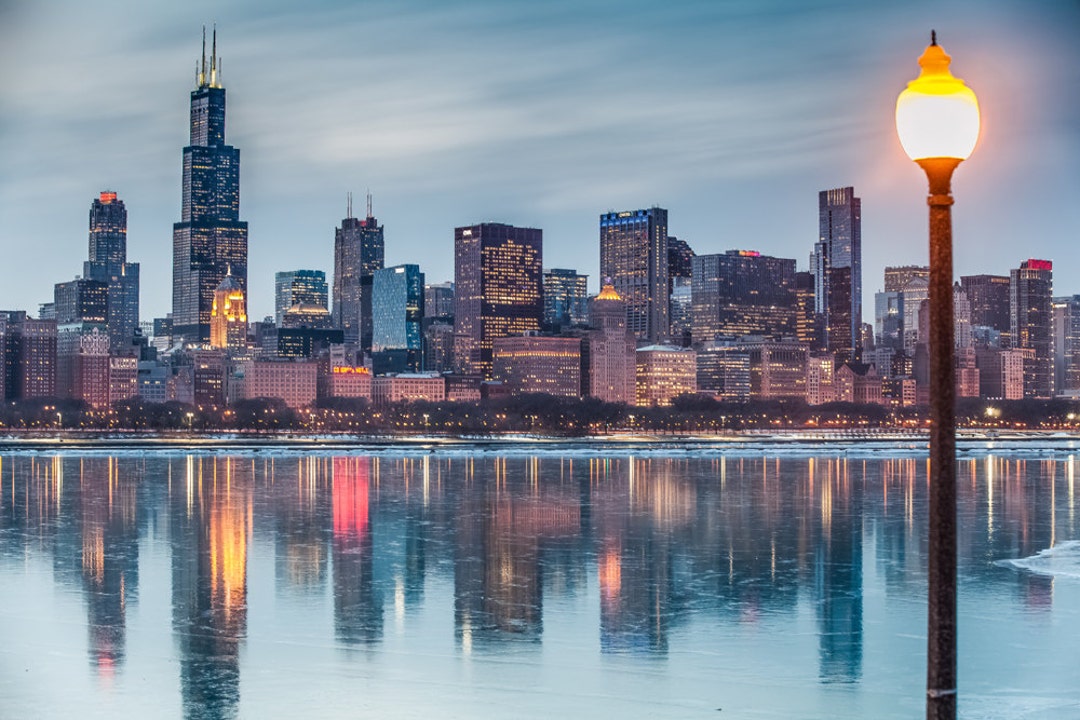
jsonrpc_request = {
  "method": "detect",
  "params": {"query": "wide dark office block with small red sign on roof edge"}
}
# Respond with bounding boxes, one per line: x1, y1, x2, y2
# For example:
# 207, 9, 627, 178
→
691, 250, 797, 343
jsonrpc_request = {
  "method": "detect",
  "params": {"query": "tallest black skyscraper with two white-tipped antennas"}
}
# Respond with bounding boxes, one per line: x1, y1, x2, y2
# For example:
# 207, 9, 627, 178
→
173, 30, 247, 344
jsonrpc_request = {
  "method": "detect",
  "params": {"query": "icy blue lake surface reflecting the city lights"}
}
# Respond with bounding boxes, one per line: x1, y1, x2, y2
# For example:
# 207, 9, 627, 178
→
0, 444, 1080, 719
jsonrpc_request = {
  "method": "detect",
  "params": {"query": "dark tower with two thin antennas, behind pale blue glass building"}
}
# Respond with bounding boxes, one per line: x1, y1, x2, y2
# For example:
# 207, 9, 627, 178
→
333, 193, 384, 351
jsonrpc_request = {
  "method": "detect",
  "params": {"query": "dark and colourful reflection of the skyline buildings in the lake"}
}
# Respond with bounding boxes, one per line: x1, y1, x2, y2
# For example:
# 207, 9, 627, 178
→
0, 454, 1078, 718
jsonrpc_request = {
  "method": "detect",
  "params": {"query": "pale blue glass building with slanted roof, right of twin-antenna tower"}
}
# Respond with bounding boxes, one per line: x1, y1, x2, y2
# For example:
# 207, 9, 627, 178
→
372, 264, 424, 373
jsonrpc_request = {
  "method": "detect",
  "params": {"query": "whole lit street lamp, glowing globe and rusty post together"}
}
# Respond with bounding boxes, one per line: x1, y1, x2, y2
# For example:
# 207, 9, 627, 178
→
896, 32, 978, 720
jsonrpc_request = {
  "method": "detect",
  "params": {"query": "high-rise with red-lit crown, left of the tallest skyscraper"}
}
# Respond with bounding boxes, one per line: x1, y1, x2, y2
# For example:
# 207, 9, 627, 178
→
82, 191, 139, 352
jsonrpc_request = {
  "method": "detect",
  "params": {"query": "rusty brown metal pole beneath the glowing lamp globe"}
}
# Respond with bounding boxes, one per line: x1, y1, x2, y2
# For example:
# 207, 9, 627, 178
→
919, 158, 960, 720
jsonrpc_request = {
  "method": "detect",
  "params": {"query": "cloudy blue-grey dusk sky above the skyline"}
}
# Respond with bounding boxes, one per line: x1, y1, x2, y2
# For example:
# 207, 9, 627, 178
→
0, 0, 1080, 321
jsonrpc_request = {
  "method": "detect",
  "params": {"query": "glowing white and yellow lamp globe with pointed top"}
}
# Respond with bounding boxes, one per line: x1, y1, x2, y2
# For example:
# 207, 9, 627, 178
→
896, 35, 978, 162
